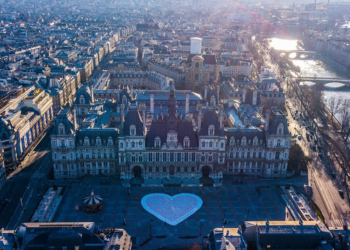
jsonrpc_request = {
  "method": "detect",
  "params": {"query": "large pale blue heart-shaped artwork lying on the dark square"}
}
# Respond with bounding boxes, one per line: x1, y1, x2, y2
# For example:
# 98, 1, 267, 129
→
141, 193, 203, 226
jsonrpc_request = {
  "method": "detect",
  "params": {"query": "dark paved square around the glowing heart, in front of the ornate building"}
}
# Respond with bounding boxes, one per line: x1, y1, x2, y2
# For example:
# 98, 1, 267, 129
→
54, 183, 287, 247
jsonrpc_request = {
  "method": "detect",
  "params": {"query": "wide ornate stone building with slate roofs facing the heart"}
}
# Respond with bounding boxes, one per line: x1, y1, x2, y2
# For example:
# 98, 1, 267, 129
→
51, 85, 291, 184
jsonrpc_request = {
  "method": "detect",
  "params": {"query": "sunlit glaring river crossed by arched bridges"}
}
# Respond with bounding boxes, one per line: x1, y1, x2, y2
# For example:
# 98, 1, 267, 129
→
269, 38, 350, 119
